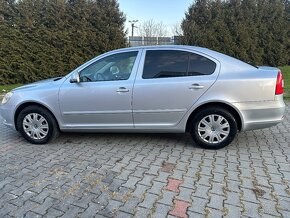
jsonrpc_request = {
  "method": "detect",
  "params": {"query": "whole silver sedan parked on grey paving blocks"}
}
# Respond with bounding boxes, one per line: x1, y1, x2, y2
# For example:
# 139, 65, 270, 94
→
0, 46, 285, 149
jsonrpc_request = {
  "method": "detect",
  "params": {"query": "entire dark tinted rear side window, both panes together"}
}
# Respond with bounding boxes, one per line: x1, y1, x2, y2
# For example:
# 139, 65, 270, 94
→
142, 50, 216, 79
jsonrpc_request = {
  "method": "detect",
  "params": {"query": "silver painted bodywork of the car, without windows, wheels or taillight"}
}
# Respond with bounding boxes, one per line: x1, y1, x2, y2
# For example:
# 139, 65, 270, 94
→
0, 46, 285, 132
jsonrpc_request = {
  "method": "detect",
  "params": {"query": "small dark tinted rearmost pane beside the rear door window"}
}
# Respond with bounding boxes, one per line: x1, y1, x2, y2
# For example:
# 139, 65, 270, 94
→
188, 54, 216, 76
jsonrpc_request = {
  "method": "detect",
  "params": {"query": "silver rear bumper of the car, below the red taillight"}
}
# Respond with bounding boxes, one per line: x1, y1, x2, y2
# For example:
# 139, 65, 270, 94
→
234, 95, 286, 131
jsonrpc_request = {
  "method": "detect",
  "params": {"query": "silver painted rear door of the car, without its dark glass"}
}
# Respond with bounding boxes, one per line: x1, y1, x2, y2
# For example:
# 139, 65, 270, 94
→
133, 47, 220, 127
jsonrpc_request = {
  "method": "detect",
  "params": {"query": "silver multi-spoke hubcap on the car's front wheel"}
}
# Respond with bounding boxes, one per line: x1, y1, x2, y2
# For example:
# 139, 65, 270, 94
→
22, 113, 49, 139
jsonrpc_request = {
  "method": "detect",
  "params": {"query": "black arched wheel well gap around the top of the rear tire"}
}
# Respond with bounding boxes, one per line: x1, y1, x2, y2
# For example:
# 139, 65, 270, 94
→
185, 102, 243, 132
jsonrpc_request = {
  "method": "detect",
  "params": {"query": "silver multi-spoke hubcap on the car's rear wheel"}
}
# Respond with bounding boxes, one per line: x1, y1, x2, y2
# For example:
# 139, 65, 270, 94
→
198, 114, 230, 144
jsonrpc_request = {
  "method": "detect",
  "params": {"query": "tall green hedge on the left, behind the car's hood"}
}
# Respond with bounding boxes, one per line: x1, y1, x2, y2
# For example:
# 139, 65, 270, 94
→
0, 0, 126, 84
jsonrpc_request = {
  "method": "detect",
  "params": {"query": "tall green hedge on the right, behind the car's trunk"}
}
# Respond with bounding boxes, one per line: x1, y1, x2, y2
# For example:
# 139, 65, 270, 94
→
182, 0, 290, 66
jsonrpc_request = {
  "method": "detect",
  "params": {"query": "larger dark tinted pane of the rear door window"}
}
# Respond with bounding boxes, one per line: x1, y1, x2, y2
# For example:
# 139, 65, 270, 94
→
142, 50, 189, 79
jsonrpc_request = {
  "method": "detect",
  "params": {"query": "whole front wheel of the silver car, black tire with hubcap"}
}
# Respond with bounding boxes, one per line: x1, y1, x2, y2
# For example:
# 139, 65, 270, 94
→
16, 105, 59, 144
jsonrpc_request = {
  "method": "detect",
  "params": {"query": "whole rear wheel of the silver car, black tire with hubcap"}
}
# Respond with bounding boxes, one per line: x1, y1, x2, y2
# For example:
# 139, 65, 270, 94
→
190, 107, 238, 149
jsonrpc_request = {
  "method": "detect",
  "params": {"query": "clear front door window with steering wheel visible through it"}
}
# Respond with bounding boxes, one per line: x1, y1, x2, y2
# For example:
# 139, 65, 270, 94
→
80, 51, 138, 82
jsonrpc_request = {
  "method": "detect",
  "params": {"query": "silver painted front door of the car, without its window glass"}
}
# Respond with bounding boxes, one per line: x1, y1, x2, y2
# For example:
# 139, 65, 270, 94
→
59, 49, 142, 129
